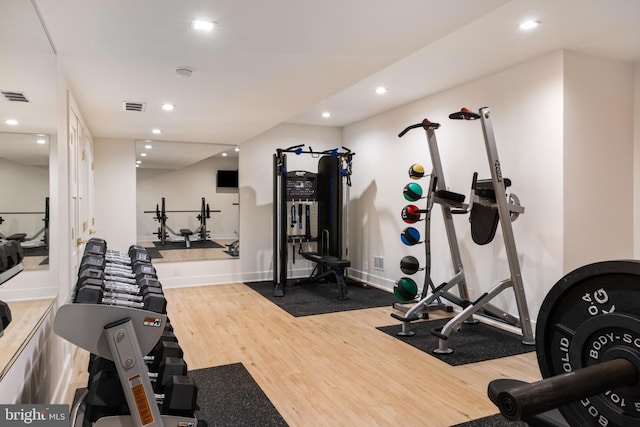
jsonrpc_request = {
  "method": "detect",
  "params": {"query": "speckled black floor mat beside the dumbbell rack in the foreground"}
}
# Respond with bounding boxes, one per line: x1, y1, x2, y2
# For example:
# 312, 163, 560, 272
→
189, 363, 287, 427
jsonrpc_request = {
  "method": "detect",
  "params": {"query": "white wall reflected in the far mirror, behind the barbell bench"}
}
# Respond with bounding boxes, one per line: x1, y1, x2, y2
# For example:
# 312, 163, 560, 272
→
136, 156, 239, 242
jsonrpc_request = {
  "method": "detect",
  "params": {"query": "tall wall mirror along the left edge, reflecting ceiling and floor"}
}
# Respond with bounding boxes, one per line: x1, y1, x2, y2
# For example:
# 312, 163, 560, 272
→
0, 0, 58, 379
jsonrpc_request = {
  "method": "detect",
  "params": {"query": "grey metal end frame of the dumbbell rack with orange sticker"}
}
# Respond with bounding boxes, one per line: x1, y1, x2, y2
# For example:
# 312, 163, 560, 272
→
54, 244, 198, 427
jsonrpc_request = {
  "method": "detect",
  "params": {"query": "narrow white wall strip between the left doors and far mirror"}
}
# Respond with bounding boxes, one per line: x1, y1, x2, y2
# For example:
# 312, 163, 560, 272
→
93, 138, 136, 251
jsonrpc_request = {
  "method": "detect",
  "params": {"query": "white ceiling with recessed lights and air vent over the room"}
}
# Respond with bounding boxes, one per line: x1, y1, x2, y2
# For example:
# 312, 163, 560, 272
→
0, 0, 640, 154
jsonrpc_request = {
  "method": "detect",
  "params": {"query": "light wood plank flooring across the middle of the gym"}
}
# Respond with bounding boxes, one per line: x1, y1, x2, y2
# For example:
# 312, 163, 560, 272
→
69, 284, 540, 427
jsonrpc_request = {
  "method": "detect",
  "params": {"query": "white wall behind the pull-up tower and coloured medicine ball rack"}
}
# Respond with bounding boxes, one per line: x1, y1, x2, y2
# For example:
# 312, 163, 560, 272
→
343, 53, 563, 319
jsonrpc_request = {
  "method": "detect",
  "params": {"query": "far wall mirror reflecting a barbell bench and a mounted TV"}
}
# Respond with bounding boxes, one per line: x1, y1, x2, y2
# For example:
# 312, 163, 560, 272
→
136, 140, 240, 262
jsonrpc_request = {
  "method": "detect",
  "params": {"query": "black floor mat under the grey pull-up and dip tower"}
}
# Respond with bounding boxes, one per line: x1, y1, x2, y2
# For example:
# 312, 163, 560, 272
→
378, 319, 536, 366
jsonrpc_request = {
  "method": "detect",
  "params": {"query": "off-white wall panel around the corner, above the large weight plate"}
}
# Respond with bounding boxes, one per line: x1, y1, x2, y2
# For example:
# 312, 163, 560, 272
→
563, 52, 637, 271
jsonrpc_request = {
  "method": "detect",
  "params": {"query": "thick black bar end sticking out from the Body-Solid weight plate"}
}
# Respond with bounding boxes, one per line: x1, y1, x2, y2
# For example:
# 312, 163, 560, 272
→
496, 358, 638, 421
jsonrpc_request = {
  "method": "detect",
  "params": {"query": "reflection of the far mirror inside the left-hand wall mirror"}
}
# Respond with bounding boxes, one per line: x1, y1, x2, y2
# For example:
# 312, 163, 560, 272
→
0, 132, 50, 270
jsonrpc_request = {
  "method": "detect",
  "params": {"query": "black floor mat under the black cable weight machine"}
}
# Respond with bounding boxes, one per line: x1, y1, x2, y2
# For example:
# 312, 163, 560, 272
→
246, 281, 397, 317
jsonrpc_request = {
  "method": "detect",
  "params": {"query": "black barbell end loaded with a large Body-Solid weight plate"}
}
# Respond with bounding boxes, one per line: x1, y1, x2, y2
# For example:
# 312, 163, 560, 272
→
489, 260, 640, 427
